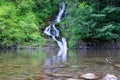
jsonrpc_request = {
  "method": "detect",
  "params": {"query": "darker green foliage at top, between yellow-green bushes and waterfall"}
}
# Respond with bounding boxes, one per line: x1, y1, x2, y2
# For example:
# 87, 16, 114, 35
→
33, 0, 60, 24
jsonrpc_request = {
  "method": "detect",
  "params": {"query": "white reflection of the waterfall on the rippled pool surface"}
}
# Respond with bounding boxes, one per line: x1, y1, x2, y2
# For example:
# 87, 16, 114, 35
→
44, 49, 67, 73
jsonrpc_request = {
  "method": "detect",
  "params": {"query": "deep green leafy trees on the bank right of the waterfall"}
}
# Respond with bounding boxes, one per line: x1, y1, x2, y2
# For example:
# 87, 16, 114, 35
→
61, 0, 120, 47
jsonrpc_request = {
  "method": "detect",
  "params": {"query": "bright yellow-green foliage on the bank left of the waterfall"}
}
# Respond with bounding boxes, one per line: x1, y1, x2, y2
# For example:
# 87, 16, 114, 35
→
0, 0, 58, 47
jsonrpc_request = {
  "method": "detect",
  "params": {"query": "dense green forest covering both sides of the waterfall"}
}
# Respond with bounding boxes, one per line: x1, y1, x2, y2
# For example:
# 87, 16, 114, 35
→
0, 0, 120, 48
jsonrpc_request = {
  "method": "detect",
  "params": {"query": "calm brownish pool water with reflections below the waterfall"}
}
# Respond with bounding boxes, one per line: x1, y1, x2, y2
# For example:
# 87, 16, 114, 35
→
0, 49, 120, 80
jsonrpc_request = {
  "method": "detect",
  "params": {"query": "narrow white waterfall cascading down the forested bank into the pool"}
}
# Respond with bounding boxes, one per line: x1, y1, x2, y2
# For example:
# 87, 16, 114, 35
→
44, 2, 67, 49
